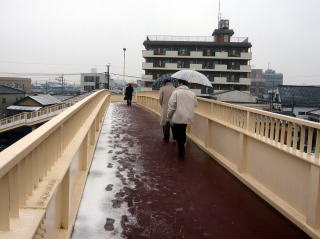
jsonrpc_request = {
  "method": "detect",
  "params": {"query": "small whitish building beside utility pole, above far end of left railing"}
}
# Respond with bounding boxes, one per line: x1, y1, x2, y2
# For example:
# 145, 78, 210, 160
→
80, 69, 107, 91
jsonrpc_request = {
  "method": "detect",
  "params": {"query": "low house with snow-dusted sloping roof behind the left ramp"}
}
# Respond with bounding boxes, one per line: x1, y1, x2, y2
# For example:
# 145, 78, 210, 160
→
7, 95, 62, 115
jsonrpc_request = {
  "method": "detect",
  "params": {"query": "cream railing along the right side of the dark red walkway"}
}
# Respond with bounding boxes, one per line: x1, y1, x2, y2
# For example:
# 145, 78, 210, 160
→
137, 92, 320, 238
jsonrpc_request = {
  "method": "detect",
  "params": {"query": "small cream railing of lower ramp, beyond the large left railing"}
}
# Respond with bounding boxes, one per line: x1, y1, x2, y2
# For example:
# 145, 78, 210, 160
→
0, 94, 88, 132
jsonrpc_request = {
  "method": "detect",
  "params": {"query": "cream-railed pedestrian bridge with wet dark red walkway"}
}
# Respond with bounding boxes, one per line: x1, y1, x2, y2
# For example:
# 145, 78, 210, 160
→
0, 91, 320, 239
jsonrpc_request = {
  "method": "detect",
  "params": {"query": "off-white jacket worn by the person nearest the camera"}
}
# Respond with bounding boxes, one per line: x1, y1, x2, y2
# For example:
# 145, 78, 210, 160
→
168, 85, 198, 124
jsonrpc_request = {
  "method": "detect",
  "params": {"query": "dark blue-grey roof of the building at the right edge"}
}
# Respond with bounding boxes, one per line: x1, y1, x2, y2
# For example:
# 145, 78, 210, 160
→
278, 85, 320, 107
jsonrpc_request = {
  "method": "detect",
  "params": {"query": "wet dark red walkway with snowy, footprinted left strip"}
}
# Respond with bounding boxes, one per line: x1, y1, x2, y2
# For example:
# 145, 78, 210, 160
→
72, 103, 309, 239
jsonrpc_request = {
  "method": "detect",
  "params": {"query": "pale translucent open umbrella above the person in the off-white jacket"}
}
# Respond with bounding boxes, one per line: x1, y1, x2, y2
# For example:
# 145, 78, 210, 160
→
171, 70, 212, 87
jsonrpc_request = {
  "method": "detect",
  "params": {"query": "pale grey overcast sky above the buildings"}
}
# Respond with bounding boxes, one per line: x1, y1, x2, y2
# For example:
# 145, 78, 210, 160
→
0, 0, 320, 84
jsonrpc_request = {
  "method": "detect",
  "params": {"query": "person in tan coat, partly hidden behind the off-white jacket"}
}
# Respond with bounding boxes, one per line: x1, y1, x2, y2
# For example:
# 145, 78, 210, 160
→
159, 79, 175, 142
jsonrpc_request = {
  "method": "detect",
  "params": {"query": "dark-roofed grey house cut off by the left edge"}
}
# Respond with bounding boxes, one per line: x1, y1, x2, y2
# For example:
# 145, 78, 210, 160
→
0, 85, 26, 118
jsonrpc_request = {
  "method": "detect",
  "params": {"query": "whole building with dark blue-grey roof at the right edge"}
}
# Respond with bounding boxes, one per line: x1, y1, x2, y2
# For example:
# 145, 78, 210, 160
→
274, 85, 320, 119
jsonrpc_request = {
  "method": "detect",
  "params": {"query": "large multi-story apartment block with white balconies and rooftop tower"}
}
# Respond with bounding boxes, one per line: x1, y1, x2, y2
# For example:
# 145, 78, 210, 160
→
142, 20, 252, 92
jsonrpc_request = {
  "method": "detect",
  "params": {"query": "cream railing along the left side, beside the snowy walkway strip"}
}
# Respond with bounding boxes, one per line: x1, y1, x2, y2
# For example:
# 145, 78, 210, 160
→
0, 90, 110, 239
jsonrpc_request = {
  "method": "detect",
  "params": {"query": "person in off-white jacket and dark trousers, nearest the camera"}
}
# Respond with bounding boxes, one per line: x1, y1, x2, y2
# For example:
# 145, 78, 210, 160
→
167, 80, 198, 158
